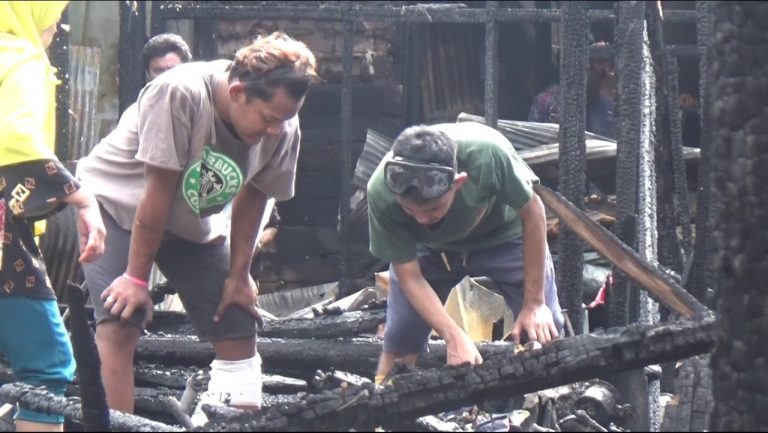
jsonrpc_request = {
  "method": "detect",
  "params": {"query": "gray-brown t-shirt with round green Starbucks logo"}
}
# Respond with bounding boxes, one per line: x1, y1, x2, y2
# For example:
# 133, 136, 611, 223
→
77, 60, 301, 243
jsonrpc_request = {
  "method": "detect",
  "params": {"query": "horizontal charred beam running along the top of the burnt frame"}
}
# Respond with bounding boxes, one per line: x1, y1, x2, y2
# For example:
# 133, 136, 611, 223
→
160, 1, 696, 23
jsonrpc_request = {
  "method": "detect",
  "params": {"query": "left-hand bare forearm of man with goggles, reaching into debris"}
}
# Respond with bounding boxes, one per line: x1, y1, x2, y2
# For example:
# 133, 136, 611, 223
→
393, 260, 483, 365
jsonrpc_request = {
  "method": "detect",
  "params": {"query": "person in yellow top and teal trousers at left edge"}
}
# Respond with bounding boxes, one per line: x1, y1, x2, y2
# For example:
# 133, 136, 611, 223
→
0, 1, 106, 431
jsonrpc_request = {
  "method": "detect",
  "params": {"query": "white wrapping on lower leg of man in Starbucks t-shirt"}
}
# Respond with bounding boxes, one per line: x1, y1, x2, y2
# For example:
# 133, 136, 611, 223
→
207, 353, 261, 407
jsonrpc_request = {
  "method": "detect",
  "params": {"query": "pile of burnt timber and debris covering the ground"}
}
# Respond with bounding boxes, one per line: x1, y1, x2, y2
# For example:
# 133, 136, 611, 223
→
0, 276, 715, 431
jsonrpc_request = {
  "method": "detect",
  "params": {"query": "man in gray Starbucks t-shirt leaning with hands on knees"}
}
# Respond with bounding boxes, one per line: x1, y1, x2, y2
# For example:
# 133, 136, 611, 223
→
78, 33, 317, 412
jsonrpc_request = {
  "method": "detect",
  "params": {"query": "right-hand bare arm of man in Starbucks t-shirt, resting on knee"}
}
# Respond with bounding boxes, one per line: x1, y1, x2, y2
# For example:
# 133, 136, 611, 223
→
213, 183, 267, 326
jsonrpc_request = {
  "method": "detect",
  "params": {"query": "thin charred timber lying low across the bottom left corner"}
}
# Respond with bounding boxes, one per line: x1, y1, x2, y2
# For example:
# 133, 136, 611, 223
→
0, 383, 183, 432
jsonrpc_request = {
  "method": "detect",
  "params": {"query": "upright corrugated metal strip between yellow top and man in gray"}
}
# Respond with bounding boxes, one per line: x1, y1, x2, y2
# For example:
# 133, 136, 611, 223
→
69, 45, 101, 159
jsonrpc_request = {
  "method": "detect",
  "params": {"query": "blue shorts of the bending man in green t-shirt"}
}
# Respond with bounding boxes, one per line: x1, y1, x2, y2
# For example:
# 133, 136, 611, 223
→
384, 240, 564, 354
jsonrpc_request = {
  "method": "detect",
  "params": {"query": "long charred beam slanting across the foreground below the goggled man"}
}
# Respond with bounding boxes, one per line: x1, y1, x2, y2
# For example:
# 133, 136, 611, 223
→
204, 319, 717, 431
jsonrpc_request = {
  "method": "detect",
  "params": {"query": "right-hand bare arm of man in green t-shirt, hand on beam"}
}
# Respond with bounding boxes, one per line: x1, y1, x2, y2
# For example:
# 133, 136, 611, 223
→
512, 193, 558, 344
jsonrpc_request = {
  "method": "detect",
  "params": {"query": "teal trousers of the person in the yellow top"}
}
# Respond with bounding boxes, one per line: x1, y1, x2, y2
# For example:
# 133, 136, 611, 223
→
0, 296, 75, 424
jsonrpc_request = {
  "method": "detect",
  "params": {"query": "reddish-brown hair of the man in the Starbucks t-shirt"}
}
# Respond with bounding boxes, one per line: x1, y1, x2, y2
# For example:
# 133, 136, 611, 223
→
229, 32, 319, 102
